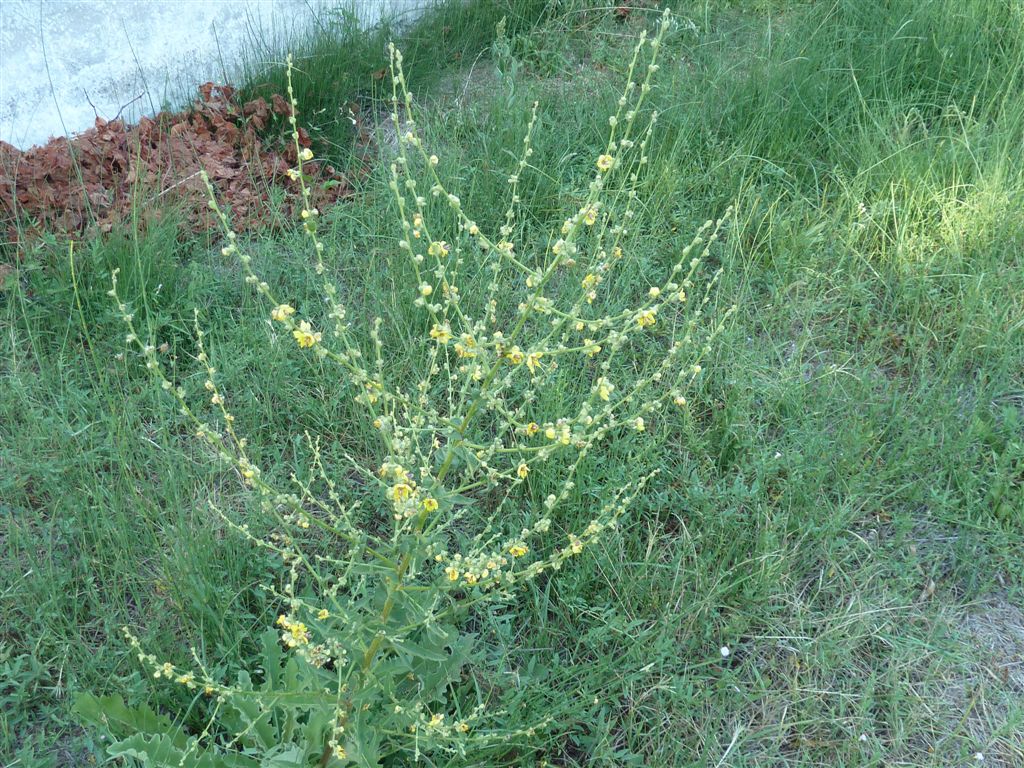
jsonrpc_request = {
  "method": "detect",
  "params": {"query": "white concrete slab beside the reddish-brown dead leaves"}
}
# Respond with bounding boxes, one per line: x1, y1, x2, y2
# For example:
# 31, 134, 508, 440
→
0, 0, 422, 148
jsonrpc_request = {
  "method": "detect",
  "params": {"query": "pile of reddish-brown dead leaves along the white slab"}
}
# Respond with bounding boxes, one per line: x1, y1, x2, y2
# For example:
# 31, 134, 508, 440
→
0, 83, 366, 244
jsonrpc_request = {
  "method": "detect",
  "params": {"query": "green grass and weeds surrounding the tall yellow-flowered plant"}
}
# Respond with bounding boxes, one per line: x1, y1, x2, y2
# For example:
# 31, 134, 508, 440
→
0, 0, 1024, 768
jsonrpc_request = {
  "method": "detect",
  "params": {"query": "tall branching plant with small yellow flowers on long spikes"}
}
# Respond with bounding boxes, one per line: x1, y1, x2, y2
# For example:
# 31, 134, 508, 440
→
78, 12, 728, 768
